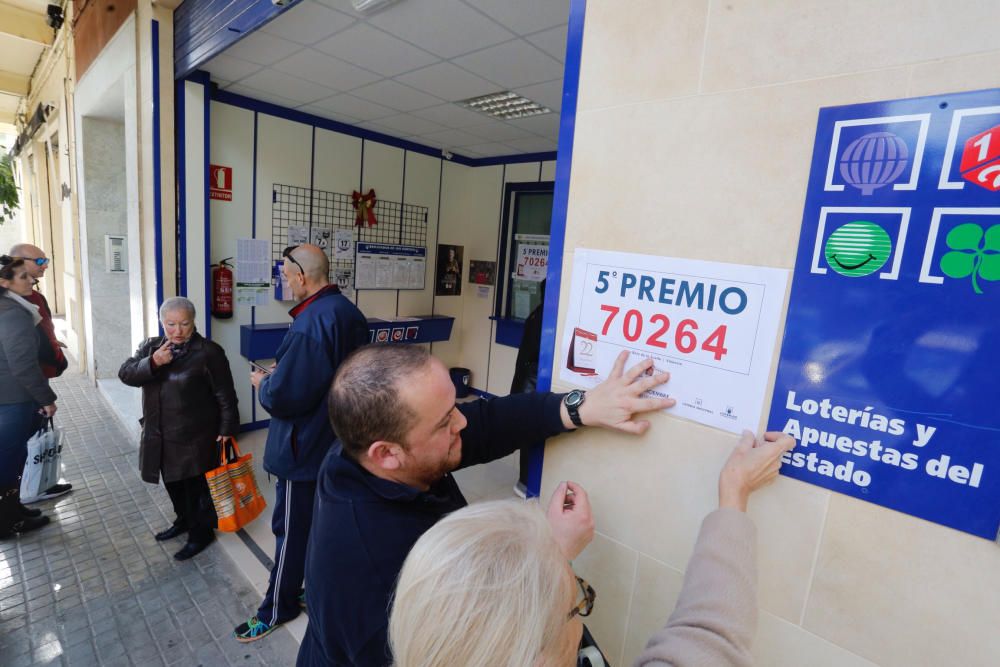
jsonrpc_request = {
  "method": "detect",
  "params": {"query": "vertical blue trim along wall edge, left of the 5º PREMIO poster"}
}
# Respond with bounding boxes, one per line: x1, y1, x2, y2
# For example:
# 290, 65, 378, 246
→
526, 0, 587, 496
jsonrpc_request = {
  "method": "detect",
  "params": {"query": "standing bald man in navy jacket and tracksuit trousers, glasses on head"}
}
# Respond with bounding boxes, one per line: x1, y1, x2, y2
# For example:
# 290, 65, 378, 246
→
234, 244, 368, 642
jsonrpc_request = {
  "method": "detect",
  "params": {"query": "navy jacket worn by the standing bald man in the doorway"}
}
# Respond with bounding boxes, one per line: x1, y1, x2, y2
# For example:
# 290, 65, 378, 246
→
257, 285, 368, 481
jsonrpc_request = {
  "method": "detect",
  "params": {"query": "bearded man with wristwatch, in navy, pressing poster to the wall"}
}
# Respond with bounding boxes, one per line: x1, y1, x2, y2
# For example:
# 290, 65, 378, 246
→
297, 344, 674, 667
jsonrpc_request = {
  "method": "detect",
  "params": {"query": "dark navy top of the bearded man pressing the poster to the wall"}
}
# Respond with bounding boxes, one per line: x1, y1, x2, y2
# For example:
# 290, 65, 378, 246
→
297, 394, 565, 667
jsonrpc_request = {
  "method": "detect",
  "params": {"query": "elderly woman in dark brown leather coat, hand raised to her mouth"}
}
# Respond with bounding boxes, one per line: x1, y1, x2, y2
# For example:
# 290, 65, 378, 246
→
118, 297, 240, 560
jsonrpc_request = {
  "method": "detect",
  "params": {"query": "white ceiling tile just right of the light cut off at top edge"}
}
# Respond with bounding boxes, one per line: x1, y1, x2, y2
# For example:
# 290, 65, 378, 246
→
368, 0, 514, 58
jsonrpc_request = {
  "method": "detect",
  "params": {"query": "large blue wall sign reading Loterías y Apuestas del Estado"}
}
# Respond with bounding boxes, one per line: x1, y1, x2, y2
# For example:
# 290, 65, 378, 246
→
769, 90, 1000, 540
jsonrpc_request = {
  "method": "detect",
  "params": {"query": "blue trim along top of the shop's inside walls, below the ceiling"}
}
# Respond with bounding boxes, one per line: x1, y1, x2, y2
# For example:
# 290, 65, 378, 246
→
213, 90, 557, 167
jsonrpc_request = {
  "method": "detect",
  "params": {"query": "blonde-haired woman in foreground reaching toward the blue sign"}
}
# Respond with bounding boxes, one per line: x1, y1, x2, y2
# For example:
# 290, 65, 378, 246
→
389, 432, 795, 667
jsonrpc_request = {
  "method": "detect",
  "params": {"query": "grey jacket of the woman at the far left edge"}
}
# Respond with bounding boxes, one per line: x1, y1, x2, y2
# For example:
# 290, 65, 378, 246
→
0, 295, 56, 405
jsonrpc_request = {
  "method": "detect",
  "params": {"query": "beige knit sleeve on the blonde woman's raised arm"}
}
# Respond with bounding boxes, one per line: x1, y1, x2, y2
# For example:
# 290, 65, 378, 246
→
634, 509, 757, 667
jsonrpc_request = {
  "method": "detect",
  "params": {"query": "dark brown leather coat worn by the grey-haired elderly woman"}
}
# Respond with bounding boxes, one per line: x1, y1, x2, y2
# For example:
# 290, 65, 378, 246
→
118, 333, 240, 484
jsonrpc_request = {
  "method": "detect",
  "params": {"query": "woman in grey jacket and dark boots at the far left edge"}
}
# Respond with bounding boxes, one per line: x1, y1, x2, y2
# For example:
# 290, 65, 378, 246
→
0, 255, 56, 538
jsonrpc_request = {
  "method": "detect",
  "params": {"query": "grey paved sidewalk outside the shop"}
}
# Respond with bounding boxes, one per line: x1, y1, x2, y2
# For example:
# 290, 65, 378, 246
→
0, 373, 298, 667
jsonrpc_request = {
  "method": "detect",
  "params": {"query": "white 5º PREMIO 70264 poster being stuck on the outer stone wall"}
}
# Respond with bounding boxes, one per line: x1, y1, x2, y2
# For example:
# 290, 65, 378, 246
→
559, 249, 788, 433
